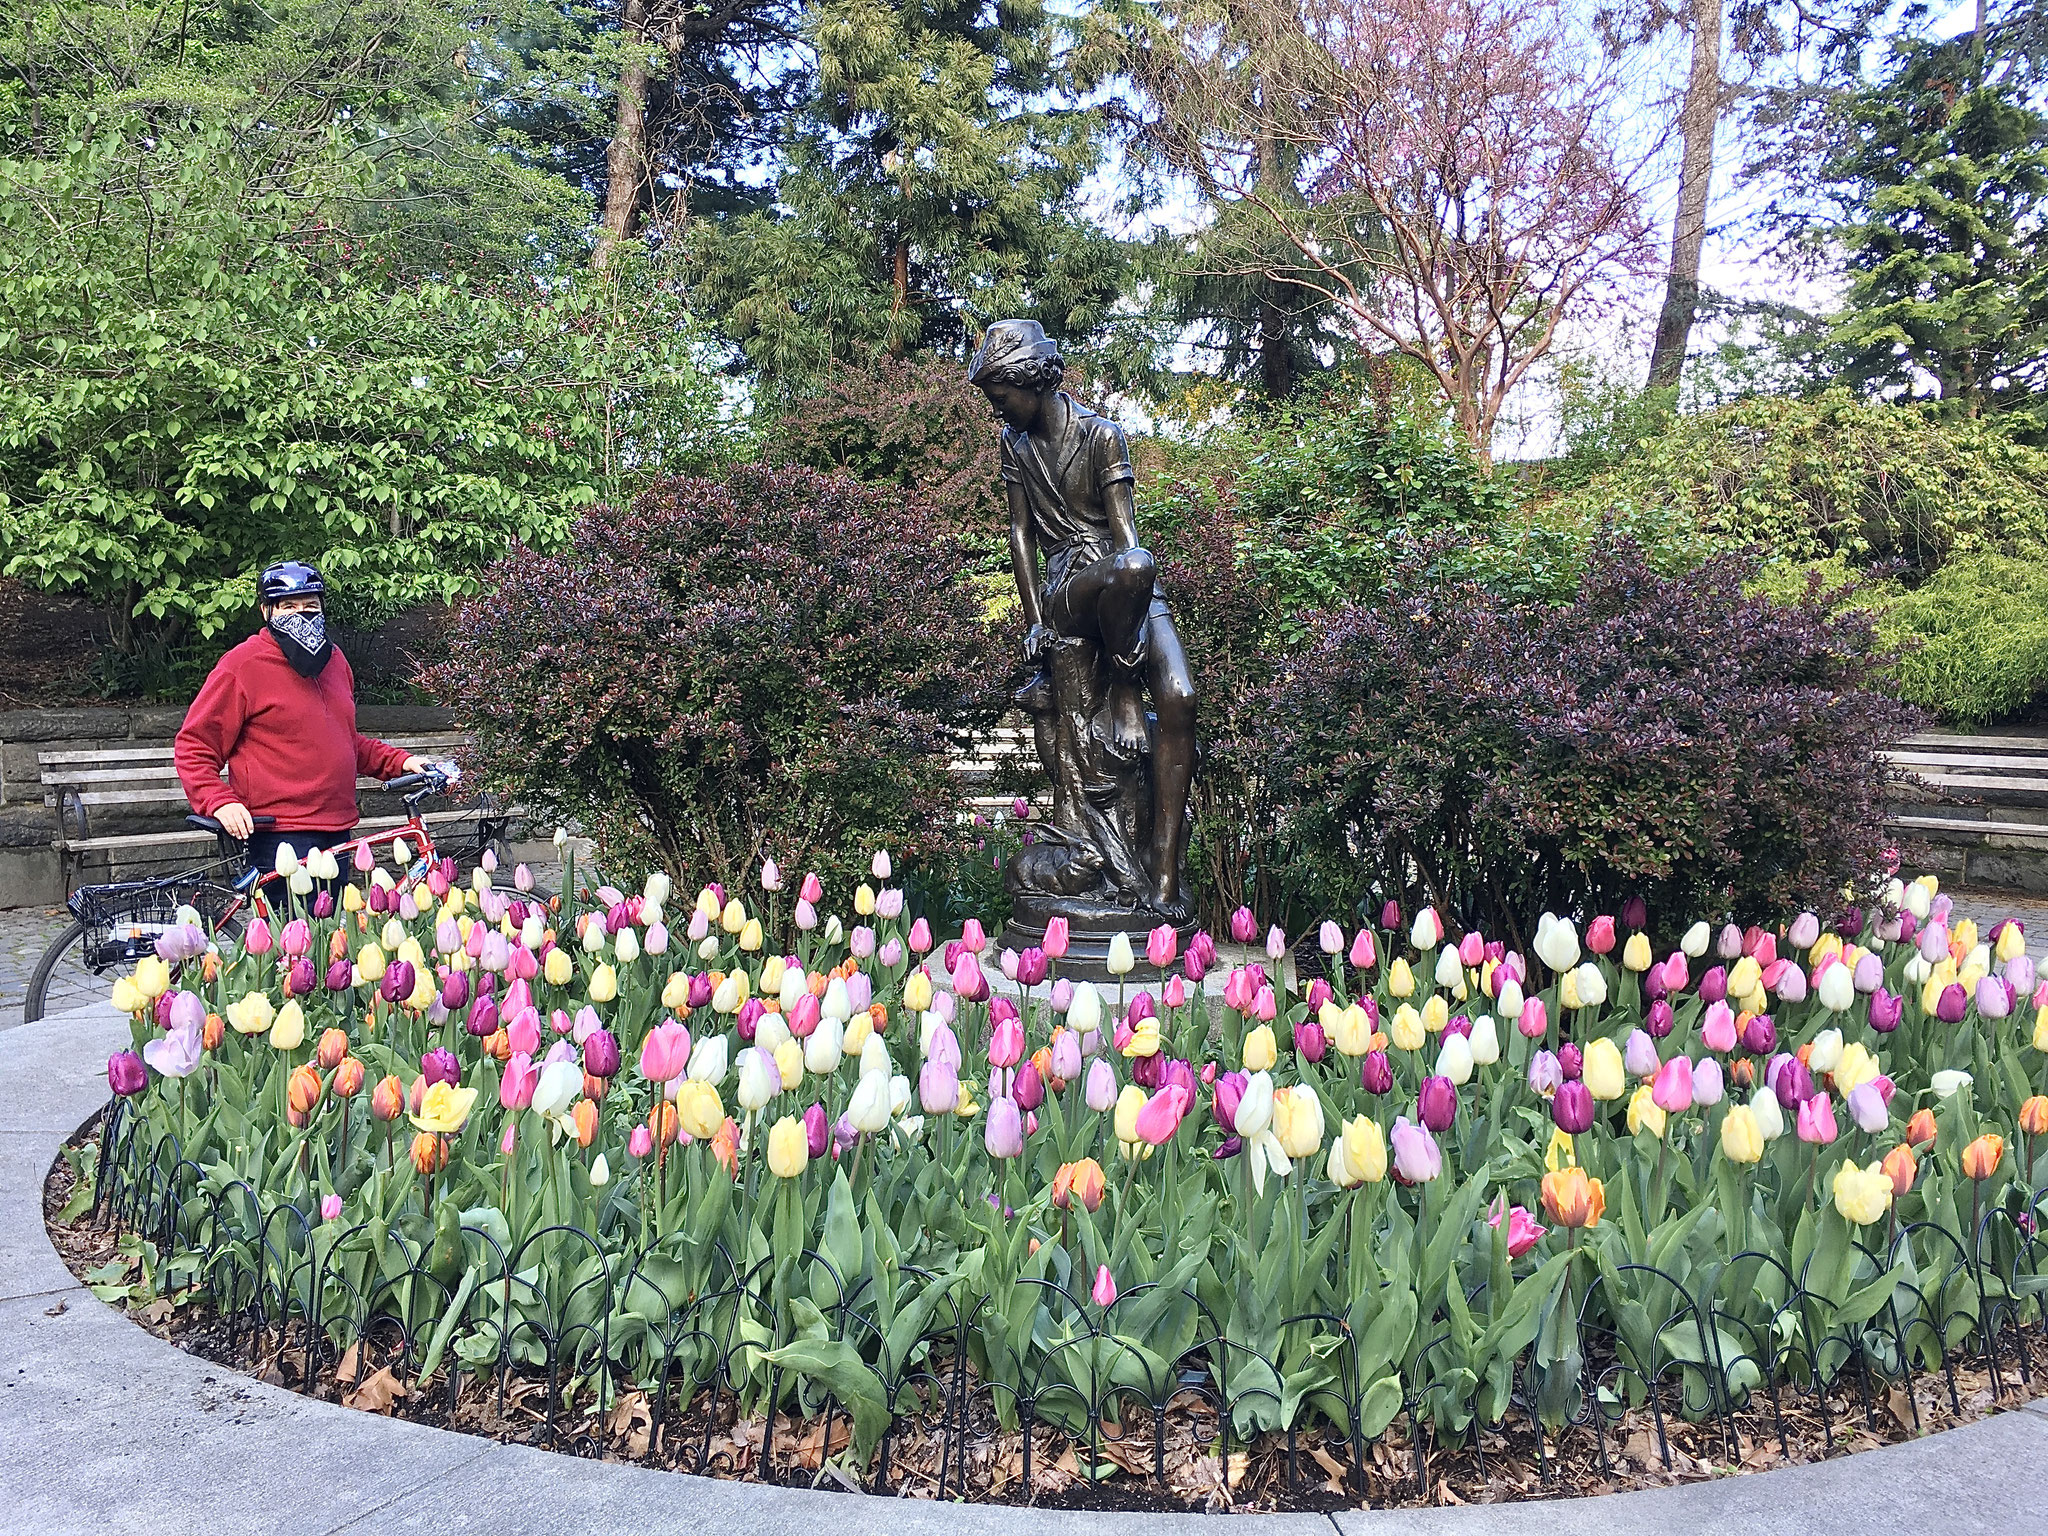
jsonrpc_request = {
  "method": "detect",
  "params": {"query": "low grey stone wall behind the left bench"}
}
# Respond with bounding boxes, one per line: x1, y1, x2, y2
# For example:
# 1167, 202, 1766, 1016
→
0, 705, 455, 907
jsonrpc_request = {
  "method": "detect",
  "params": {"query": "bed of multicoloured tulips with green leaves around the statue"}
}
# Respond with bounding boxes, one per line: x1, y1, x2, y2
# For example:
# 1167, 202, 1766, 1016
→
72, 856, 2048, 1497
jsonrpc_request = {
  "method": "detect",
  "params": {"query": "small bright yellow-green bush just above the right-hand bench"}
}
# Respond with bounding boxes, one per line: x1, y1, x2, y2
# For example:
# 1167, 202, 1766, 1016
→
1878, 555, 2048, 725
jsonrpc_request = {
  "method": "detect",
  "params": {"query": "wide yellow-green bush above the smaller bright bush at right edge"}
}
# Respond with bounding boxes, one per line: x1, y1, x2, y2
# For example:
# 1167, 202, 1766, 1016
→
1556, 389, 2048, 571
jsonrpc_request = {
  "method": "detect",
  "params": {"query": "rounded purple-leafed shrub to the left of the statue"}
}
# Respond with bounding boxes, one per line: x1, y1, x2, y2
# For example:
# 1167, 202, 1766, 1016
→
426, 465, 1008, 891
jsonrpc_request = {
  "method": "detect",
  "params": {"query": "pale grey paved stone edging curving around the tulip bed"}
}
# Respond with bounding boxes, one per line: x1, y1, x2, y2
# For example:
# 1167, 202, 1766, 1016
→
0, 1008, 2048, 1536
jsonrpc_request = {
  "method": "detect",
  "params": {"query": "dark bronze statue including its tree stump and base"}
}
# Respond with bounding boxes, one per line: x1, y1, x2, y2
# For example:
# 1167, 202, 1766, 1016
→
967, 319, 1194, 942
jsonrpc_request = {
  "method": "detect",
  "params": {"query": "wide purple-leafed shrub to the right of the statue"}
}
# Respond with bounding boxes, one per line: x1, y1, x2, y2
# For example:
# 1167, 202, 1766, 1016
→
1223, 543, 1923, 938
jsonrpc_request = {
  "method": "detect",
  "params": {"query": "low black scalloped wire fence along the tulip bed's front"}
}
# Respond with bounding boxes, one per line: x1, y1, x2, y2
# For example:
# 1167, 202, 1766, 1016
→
90, 1100, 2048, 1503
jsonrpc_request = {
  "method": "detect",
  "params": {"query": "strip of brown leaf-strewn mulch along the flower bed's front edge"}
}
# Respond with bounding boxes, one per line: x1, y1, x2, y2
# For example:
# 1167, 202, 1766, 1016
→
43, 1157, 2048, 1513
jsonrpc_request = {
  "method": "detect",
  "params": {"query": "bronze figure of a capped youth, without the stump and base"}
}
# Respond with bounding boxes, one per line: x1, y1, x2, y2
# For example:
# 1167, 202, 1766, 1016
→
967, 319, 1194, 922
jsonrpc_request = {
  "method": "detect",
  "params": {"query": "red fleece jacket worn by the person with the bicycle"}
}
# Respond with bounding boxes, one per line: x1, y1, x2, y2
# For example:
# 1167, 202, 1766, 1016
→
172, 631, 406, 831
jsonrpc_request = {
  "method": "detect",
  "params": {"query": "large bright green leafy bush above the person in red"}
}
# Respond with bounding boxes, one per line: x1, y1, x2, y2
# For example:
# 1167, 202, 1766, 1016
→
0, 119, 723, 651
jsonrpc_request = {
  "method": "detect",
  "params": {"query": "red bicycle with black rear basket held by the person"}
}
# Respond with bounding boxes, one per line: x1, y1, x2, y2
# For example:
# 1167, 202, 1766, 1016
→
23, 762, 520, 1024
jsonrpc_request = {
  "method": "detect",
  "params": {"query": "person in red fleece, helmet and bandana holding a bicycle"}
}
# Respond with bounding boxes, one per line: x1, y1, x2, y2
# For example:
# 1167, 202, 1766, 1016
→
172, 561, 428, 870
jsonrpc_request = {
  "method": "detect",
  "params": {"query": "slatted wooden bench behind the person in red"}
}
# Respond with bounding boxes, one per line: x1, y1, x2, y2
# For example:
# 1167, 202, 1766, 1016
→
37, 731, 502, 891
